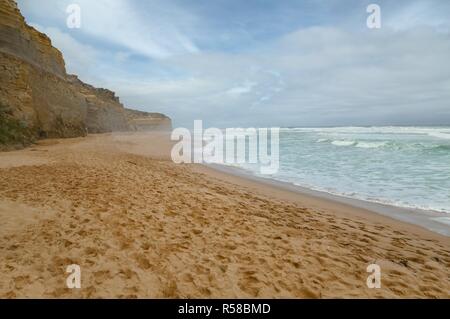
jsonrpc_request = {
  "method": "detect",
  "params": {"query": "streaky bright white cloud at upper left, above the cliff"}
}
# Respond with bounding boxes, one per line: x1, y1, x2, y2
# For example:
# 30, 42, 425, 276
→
19, 0, 199, 59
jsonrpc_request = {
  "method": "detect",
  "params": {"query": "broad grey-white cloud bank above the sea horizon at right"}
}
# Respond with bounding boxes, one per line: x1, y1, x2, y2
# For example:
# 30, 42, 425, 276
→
118, 27, 450, 126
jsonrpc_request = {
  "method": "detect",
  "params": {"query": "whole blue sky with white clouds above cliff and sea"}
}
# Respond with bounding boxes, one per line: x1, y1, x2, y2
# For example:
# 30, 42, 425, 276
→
17, 0, 450, 128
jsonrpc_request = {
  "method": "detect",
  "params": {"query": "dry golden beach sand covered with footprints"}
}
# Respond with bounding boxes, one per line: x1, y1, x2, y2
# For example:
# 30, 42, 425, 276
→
0, 133, 450, 298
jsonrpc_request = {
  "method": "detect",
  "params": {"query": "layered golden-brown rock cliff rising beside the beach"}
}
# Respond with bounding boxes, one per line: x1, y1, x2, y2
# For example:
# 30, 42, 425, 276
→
0, 0, 171, 148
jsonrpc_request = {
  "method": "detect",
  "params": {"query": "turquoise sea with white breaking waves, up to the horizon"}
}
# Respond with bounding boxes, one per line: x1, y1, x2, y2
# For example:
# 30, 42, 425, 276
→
232, 127, 450, 213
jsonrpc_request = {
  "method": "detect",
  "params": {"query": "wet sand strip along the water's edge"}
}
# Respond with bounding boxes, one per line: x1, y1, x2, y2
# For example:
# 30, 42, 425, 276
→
200, 164, 450, 237
